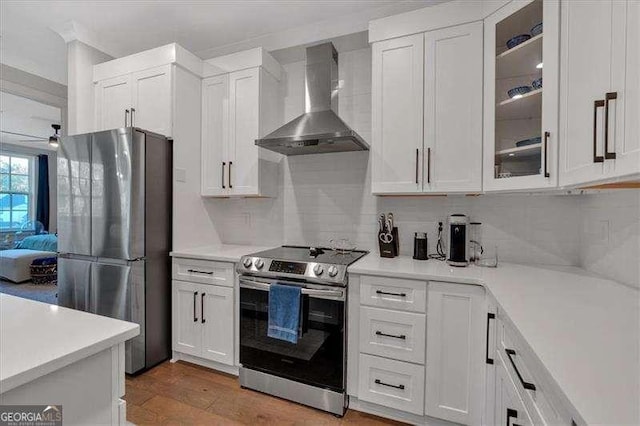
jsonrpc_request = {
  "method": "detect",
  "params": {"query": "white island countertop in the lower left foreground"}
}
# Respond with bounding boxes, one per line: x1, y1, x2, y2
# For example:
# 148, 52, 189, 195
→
0, 294, 140, 393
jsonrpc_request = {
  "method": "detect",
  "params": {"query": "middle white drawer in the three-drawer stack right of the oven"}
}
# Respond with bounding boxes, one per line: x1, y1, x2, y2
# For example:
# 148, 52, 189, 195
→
360, 306, 426, 364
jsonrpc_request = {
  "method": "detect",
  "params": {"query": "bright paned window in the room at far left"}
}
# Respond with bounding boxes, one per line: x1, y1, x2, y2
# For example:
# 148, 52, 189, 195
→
0, 154, 34, 231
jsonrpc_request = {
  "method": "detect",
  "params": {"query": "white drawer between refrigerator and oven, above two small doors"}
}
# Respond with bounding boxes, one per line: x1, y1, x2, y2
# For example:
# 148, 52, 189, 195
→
173, 257, 233, 287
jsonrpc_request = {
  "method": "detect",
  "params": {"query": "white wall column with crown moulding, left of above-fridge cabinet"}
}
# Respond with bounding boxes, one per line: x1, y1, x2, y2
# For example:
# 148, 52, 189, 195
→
67, 40, 113, 135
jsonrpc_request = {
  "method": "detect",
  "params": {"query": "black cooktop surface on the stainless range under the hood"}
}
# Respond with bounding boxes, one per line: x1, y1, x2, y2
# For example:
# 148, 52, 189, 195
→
251, 246, 369, 266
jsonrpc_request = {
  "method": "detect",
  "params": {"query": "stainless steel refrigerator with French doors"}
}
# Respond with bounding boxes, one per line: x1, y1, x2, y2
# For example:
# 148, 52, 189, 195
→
57, 127, 172, 374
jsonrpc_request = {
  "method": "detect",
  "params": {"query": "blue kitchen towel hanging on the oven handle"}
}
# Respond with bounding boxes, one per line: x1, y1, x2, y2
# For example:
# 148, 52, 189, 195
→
267, 284, 302, 343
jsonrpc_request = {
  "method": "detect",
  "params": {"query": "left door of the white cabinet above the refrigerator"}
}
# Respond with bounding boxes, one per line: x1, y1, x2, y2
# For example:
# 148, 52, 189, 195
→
95, 75, 132, 130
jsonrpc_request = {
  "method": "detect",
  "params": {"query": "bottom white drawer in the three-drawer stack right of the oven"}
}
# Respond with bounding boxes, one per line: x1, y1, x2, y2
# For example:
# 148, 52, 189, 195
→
358, 354, 424, 416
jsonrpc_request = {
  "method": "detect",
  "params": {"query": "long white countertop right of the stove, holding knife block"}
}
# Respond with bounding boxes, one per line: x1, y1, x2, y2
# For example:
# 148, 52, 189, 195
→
349, 253, 640, 424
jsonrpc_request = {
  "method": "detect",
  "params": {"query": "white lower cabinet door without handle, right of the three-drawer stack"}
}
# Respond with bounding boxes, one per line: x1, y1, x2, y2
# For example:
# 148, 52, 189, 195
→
425, 281, 486, 424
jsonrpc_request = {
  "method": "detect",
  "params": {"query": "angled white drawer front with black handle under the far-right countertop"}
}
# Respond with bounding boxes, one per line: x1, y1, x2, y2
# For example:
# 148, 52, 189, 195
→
498, 316, 571, 425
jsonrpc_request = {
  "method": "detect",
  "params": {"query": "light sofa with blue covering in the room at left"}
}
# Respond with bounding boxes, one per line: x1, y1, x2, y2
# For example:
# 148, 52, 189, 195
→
0, 234, 58, 283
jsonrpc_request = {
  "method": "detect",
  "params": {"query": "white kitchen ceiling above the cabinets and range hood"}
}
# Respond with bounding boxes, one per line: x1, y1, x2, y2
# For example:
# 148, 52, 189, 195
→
0, 0, 442, 83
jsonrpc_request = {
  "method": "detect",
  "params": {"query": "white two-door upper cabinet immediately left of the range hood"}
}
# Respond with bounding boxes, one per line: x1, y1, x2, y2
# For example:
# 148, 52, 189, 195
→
202, 51, 283, 197
